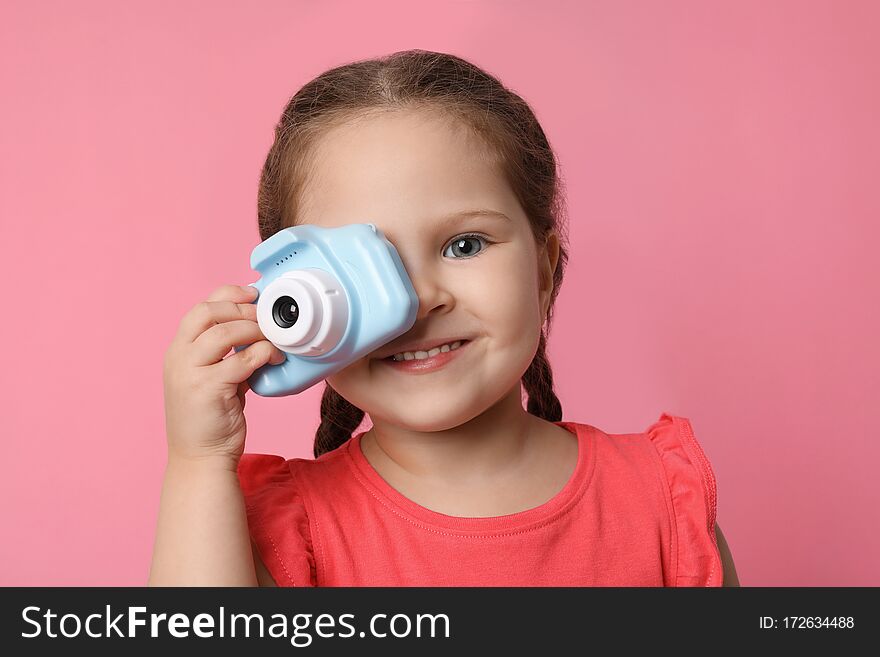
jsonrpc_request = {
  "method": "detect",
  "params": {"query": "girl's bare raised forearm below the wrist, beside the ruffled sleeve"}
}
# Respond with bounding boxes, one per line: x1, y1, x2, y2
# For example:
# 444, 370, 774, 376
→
147, 458, 258, 586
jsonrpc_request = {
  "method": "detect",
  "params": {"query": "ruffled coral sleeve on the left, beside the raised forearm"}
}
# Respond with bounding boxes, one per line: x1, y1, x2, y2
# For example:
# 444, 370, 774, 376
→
238, 454, 316, 586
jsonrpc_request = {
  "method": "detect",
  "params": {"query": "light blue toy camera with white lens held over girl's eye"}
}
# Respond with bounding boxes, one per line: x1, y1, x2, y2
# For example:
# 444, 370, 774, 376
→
235, 223, 419, 397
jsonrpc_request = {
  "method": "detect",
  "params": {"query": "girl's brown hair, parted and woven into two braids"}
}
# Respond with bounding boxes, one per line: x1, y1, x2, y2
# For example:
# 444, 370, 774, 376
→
258, 50, 568, 458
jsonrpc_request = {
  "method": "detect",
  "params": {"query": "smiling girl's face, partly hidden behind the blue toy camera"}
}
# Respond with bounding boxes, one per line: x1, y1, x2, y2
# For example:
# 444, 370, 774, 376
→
298, 111, 558, 432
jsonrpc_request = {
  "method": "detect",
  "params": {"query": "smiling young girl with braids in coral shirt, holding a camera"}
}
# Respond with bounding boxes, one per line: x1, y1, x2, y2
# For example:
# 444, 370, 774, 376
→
149, 51, 737, 586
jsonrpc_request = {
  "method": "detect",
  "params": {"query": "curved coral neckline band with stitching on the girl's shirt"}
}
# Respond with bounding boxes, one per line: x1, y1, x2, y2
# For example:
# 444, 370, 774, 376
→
345, 421, 595, 533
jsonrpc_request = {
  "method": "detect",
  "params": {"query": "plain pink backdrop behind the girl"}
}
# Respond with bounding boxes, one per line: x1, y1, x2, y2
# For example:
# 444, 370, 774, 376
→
0, 0, 880, 586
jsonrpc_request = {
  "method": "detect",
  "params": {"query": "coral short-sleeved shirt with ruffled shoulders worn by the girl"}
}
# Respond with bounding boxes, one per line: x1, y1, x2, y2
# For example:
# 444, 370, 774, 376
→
239, 413, 722, 586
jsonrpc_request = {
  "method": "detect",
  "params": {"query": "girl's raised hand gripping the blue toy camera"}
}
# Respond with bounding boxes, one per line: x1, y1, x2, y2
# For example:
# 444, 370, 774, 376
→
163, 285, 285, 465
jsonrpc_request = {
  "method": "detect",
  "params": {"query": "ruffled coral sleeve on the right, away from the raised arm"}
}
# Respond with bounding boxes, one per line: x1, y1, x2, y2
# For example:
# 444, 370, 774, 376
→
647, 413, 723, 586
